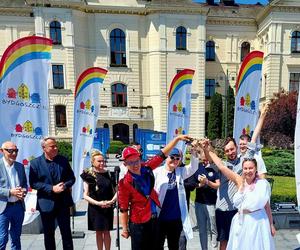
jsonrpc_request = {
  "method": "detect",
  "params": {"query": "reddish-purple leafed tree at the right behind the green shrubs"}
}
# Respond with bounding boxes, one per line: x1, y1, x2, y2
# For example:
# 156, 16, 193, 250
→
261, 89, 298, 148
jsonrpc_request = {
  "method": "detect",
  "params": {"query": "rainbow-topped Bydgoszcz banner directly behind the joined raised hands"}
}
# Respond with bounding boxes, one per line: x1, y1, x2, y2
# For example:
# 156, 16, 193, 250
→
167, 69, 195, 151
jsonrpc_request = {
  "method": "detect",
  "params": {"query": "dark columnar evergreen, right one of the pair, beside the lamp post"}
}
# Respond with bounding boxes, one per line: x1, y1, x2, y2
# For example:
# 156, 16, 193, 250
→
222, 86, 235, 138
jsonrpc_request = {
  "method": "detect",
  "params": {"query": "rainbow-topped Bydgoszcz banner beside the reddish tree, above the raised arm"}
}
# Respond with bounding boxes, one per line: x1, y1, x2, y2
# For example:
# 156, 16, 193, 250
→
233, 51, 264, 141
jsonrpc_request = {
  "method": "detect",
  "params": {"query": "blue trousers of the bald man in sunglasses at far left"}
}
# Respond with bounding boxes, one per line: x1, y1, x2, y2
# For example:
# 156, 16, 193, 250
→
0, 202, 24, 250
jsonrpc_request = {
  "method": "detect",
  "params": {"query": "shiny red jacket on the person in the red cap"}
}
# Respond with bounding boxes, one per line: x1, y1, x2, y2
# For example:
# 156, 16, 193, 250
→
118, 152, 166, 223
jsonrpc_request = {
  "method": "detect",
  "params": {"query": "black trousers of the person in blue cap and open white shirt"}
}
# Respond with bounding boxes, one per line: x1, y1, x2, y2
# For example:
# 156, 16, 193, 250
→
157, 219, 182, 250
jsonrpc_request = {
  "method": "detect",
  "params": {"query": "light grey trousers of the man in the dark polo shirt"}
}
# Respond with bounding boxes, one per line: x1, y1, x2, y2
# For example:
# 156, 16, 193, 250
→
195, 202, 217, 250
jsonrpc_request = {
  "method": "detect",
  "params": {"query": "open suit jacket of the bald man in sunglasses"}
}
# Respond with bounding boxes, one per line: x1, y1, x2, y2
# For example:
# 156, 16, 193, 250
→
0, 158, 27, 214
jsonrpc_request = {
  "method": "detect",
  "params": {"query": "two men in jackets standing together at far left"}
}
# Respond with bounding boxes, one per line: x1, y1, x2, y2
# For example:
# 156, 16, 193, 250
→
0, 137, 75, 250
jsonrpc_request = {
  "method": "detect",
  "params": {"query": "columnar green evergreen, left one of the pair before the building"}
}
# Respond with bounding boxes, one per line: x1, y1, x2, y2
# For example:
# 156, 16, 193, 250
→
207, 93, 223, 140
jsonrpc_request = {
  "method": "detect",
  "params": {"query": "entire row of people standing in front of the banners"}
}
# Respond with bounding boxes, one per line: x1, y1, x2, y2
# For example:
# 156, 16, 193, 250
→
0, 104, 275, 250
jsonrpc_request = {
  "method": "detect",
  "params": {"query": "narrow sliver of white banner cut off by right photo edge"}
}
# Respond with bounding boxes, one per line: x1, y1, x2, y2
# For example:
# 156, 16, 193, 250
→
295, 94, 300, 212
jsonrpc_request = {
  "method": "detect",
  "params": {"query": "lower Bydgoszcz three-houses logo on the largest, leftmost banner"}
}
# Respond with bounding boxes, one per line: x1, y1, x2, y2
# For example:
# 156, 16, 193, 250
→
11, 120, 43, 140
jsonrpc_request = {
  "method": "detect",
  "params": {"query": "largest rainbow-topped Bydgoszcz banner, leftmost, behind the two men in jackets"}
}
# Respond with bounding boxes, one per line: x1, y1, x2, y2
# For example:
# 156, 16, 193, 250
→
0, 36, 52, 224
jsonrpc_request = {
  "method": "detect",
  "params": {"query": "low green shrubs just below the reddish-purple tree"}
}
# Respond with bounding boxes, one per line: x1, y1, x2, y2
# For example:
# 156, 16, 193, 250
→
262, 148, 295, 176
